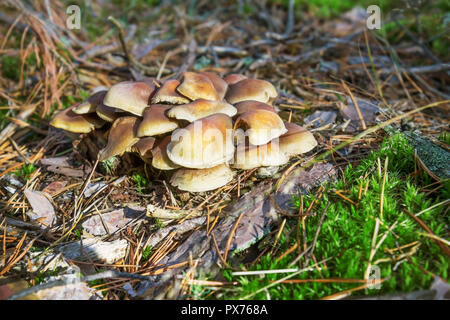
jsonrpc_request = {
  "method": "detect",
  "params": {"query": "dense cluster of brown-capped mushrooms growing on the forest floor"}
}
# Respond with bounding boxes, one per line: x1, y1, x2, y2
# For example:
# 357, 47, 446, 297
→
50, 72, 317, 192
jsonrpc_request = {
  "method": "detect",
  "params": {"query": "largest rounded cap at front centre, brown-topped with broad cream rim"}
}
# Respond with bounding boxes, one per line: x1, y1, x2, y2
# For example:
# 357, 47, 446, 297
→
167, 113, 234, 169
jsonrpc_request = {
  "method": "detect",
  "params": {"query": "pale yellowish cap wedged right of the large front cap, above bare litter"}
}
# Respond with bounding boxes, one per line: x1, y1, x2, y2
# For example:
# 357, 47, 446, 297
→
232, 141, 289, 170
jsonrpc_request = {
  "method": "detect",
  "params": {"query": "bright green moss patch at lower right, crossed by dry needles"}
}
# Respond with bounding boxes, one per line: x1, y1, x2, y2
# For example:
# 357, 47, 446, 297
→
205, 134, 450, 299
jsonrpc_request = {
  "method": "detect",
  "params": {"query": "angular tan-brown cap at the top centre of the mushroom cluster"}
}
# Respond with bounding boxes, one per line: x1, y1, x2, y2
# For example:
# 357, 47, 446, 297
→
177, 72, 220, 100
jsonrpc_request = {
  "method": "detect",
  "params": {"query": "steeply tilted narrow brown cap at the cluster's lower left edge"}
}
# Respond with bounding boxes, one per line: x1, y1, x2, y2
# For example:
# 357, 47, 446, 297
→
98, 116, 141, 161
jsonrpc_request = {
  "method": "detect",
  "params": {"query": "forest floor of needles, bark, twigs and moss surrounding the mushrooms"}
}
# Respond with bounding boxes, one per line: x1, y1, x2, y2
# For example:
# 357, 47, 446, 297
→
0, 0, 450, 300
